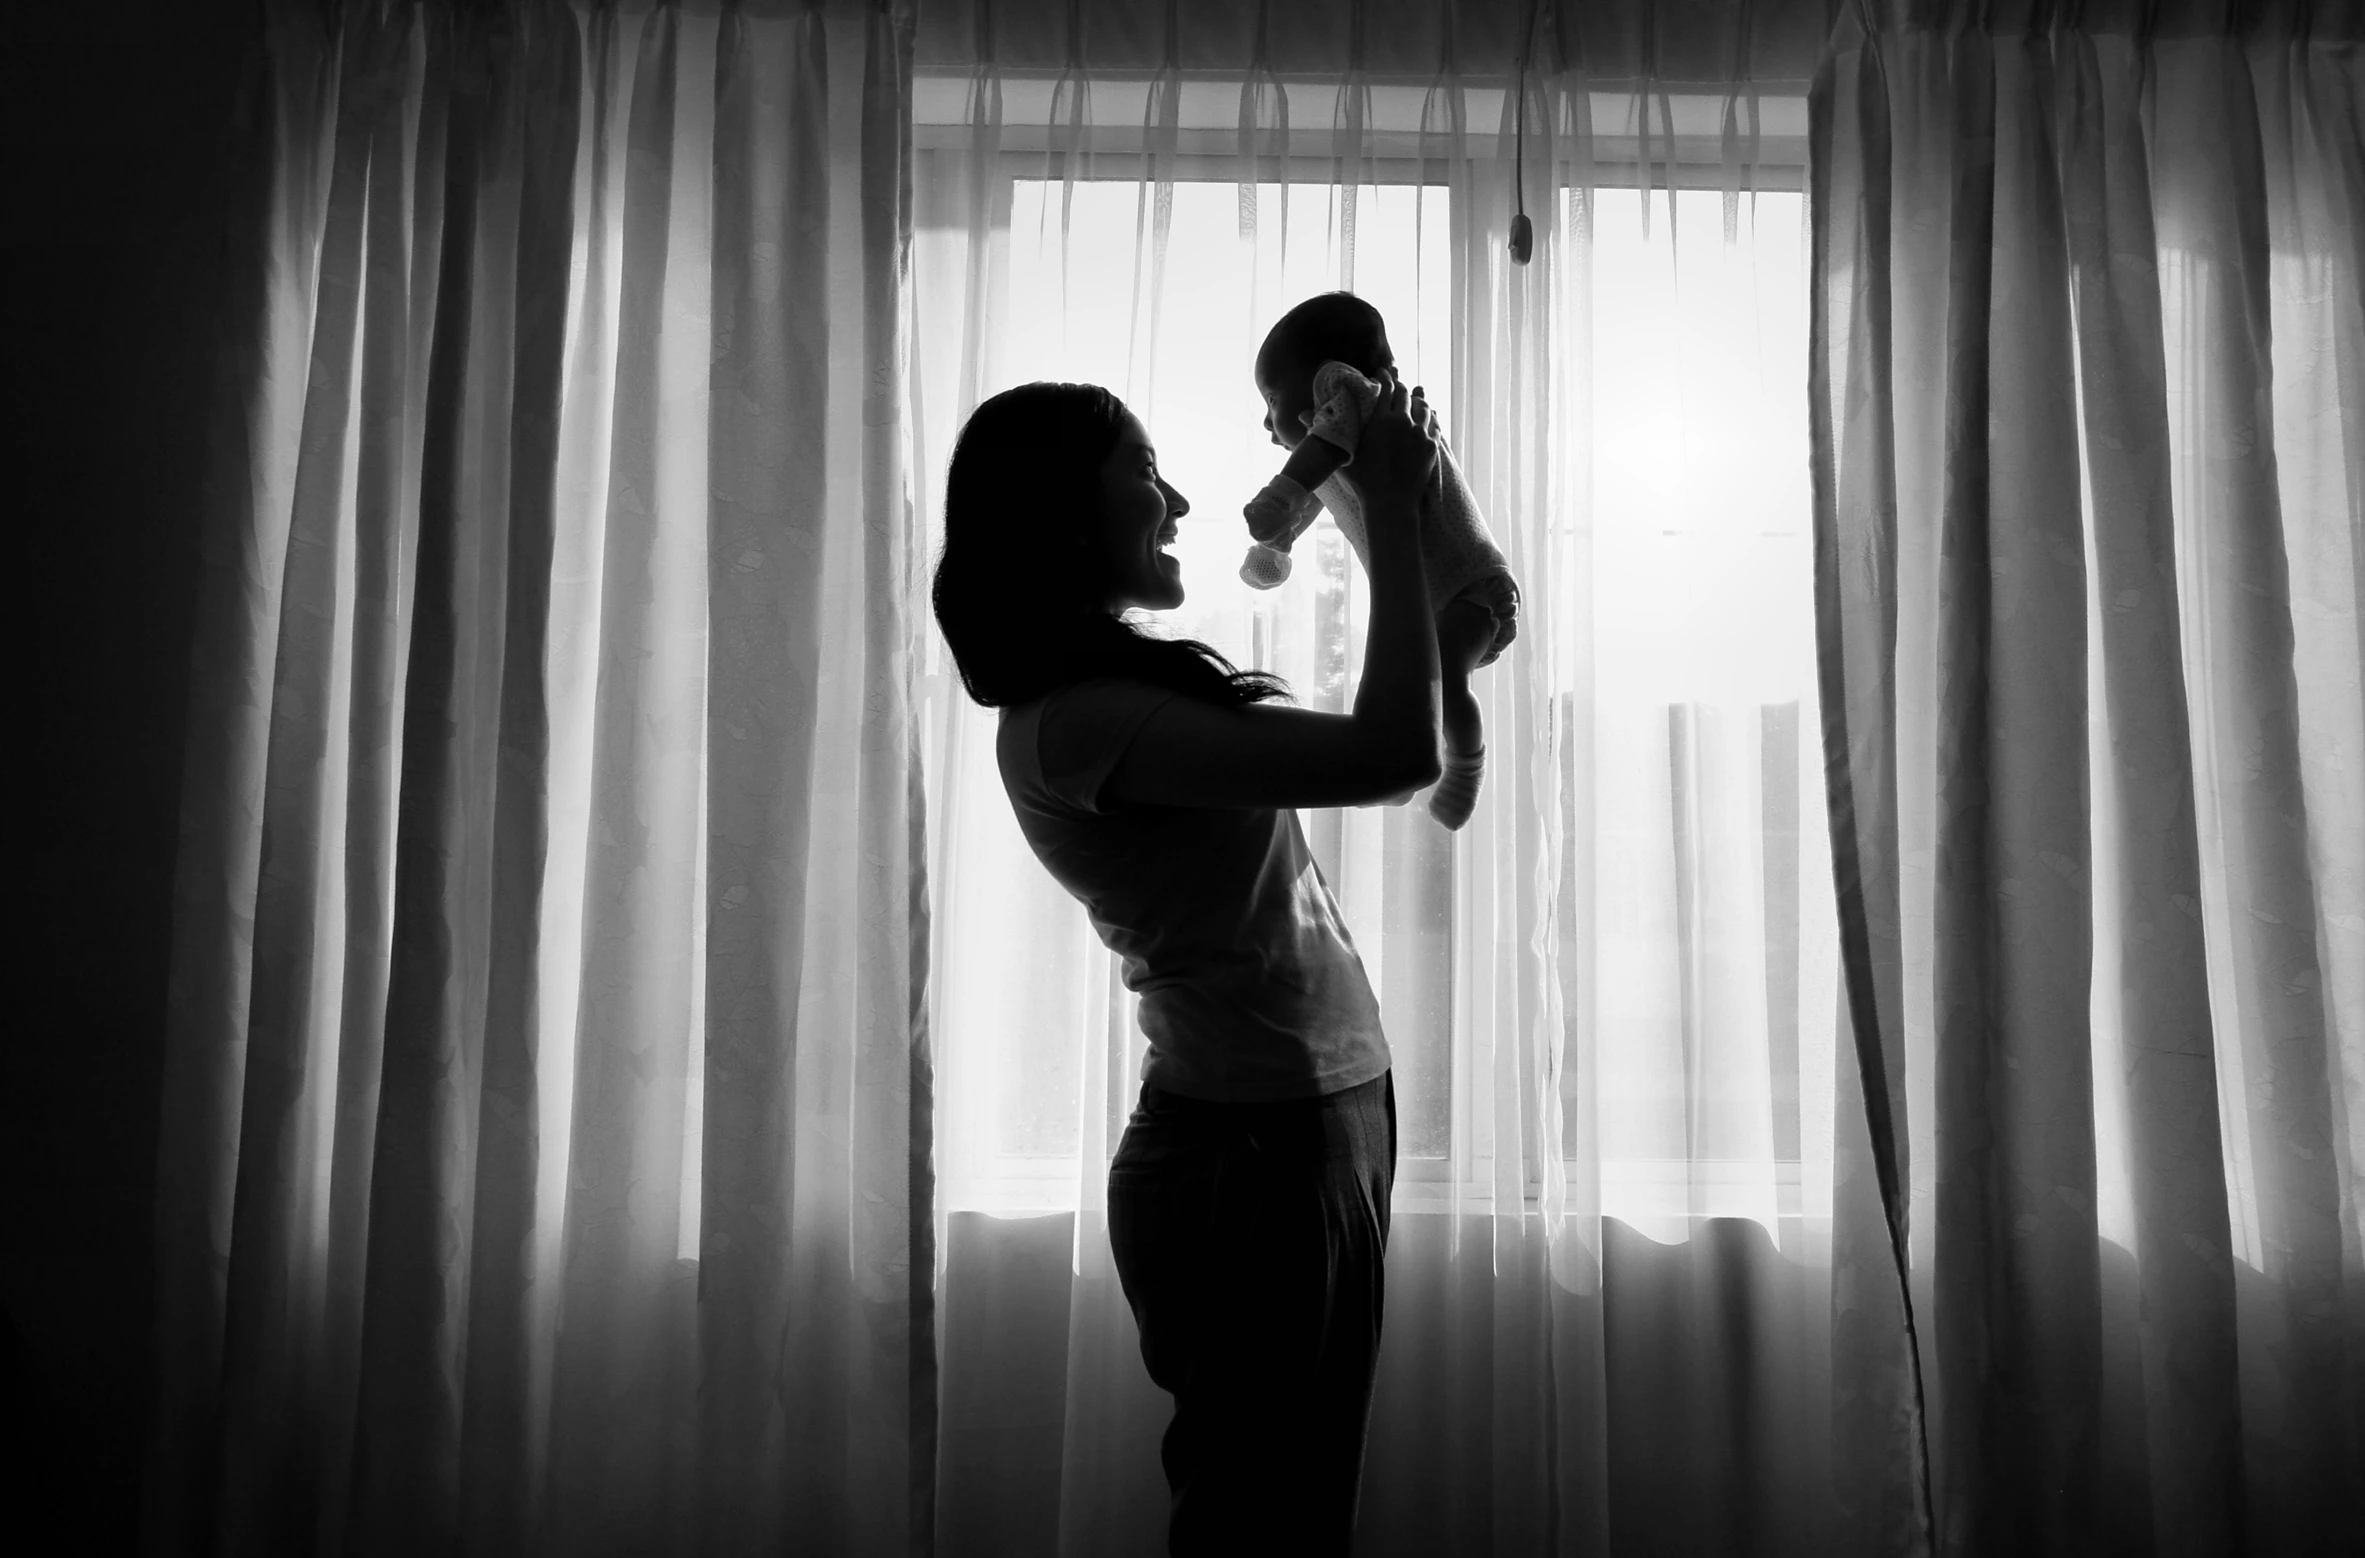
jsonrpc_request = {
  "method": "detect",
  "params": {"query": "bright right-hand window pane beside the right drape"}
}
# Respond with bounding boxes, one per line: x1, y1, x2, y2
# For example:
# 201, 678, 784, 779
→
1563, 189, 1831, 1227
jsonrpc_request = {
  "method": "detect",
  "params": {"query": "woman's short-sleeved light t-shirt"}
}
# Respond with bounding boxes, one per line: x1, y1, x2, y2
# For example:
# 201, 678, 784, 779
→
996, 679, 1388, 1104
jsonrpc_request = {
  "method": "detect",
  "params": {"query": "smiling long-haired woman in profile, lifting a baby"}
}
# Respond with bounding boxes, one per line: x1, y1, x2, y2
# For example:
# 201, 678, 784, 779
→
934, 383, 1438, 1553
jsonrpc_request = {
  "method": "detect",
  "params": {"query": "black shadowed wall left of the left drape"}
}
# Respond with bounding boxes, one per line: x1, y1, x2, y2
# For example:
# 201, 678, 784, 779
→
0, 0, 255, 1551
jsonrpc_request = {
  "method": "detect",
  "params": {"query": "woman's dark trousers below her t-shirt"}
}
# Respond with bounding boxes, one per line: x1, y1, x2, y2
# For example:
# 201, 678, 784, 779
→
1109, 1073, 1395, 1558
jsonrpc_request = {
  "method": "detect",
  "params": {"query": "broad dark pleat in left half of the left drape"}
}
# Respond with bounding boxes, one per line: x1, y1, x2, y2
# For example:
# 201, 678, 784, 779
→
341, 6, 536, 1551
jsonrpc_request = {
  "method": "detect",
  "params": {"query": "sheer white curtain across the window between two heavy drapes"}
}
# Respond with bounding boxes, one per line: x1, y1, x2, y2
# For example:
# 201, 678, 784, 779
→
911, 5, 1863, 1553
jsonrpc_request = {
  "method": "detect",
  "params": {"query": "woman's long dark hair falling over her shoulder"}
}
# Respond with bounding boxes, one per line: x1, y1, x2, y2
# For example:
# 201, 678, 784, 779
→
934, 383, 1289, 709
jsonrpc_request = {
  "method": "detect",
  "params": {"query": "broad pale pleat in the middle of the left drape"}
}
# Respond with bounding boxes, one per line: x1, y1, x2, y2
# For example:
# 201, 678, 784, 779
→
551, 7, 712, 1549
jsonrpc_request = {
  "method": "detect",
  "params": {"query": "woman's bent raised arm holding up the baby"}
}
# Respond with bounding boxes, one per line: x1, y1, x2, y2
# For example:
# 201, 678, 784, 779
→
1102, 381, 1438, 806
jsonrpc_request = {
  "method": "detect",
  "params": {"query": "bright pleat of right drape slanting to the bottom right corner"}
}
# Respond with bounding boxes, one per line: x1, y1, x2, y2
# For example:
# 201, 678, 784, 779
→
2155, 43, 2365, 1541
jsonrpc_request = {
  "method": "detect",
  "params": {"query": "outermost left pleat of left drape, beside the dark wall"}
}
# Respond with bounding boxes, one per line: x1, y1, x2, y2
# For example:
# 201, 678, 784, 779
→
142, 0, 336, 1546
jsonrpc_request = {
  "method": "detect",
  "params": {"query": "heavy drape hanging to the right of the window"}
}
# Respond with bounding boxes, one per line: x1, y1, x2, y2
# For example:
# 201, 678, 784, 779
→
1812, 5, 2365, 1553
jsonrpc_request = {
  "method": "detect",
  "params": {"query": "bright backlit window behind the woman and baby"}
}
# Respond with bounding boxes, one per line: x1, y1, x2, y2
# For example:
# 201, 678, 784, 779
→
913, 83, 1835, 1225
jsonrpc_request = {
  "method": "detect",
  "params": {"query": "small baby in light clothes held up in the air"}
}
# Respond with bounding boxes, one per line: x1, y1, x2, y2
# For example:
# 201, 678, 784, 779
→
1239, 293, 1518, 827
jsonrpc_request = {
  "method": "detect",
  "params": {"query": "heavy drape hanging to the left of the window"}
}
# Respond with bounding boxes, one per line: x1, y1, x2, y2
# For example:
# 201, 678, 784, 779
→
144, 0, 934, 1556
